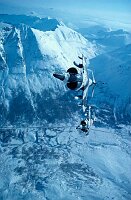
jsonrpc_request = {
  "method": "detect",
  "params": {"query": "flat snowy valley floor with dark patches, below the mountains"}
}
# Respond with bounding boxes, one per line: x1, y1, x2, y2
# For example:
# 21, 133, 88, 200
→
0, 121, 131, 200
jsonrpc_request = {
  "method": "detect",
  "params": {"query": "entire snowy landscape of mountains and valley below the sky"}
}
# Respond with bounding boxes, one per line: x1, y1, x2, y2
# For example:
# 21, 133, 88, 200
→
0, 15, 131, 200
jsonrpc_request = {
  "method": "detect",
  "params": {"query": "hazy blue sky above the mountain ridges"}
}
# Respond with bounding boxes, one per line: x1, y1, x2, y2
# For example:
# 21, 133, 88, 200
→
0, 0, 131, 28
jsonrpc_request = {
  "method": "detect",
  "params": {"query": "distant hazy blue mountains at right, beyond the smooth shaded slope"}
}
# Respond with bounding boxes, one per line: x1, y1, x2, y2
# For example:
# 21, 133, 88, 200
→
79, 25, 131, 53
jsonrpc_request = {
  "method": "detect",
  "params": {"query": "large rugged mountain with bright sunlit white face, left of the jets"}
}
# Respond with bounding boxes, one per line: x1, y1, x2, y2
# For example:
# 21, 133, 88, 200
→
0, 15, 96, 125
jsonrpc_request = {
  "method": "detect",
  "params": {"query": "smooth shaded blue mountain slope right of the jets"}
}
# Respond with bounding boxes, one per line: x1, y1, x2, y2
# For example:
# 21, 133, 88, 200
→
90, 44, 131, 121
